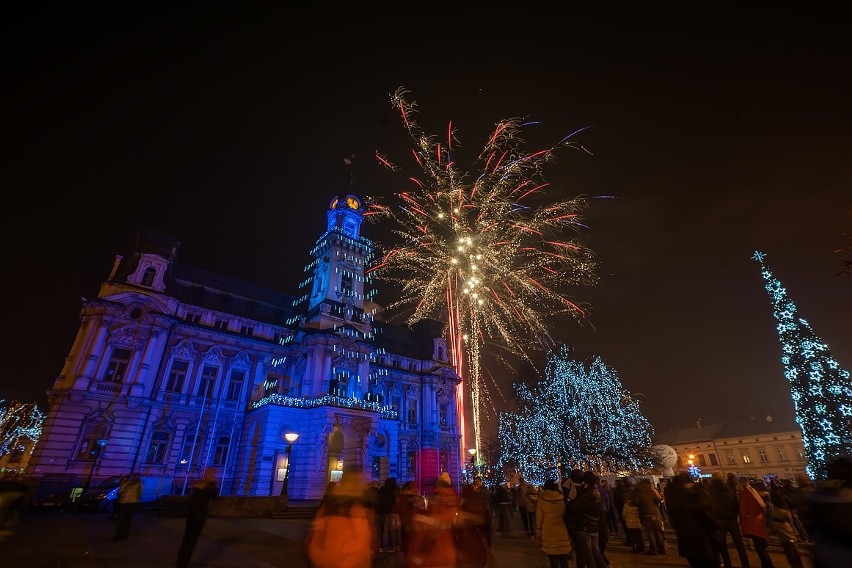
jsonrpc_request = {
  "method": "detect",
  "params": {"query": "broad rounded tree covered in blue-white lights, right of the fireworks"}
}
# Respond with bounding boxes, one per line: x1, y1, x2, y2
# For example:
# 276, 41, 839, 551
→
498, 345, 654, 484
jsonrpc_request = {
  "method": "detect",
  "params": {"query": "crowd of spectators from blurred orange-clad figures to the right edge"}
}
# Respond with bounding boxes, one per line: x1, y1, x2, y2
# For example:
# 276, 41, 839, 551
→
308, 460, 852, 568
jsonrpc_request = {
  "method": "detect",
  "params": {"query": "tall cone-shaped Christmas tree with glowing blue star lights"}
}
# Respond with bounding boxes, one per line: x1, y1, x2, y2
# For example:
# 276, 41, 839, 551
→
752, 251, 852, 479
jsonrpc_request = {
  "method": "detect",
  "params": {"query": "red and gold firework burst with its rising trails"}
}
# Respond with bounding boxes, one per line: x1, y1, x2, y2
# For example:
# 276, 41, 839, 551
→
365, 88, 597, 460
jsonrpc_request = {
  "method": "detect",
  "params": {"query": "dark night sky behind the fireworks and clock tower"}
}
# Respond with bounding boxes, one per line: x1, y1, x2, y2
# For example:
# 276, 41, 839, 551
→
0, 2, 852, 440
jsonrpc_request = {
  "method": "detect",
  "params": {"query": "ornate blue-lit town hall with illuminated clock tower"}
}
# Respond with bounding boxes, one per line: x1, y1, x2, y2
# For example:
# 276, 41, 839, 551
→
27, 195, 463, 499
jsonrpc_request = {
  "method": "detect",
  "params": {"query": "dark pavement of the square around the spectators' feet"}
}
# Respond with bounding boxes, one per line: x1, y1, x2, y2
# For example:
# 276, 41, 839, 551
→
0, 511, 813, 568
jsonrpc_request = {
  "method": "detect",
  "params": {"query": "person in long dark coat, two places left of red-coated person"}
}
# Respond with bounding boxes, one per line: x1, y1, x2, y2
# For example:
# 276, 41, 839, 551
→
665, 473, 719, 568
